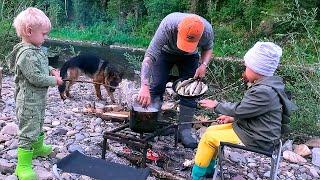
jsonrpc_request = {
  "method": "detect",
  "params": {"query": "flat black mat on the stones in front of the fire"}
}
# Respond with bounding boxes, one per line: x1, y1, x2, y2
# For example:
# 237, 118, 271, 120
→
57, 151, 150, 180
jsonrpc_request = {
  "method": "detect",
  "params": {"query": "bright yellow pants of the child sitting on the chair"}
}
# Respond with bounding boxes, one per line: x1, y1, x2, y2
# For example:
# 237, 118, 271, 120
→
195, 123, 241, 167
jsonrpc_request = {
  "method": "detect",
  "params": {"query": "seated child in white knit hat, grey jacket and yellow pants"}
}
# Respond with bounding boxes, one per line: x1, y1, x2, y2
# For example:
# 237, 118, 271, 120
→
192, 42, 296, 180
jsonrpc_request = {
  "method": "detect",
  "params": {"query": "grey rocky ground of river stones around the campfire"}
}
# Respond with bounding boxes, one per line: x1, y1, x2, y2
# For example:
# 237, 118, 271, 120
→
0, 76, 320, 180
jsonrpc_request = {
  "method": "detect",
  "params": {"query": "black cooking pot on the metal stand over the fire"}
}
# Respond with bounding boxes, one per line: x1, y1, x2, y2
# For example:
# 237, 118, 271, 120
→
129, 106, 159, 133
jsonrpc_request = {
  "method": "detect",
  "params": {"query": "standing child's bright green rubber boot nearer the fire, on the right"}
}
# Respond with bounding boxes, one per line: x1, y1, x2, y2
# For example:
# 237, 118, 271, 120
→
32, 132, 52, 158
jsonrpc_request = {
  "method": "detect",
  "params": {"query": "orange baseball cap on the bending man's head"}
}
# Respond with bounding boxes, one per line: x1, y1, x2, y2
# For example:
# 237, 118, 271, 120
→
177, 15, 204, 53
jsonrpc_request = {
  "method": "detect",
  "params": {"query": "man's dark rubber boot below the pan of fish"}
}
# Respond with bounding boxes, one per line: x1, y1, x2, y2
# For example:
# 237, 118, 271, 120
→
179, 105, 198, 149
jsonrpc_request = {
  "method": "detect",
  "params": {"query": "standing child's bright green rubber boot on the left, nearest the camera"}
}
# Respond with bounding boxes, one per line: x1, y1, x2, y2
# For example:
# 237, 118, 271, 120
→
15, 148, 37, 180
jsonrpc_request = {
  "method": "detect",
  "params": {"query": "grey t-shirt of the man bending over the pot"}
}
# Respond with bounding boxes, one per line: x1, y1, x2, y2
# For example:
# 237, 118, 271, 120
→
145, 12, 214, 61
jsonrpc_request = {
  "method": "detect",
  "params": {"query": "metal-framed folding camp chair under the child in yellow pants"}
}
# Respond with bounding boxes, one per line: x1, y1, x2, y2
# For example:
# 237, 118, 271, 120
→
213, 139, 282, 180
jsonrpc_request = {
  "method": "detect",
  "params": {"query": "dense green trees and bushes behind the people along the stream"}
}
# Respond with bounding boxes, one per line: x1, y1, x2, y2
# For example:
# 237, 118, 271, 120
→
0, 0, 320, 136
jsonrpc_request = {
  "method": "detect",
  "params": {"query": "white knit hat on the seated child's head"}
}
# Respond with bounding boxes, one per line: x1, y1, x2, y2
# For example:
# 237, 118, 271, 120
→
243, 42, 282, 76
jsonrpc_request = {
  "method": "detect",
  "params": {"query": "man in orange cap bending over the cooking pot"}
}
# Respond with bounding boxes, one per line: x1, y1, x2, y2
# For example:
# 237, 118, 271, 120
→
138, 12, 213, 148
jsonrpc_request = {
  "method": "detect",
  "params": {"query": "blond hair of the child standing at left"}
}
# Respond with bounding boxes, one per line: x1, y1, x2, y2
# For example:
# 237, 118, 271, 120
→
13, 7, 51, 37
